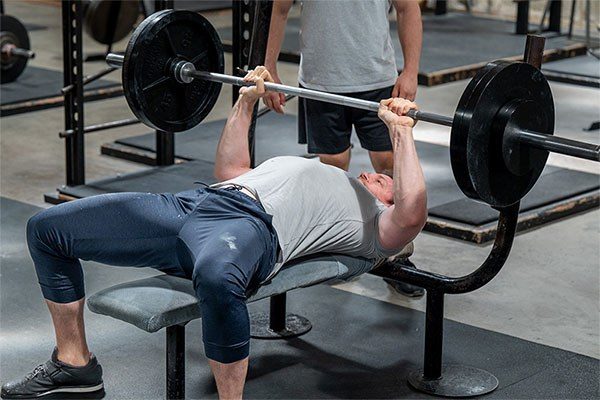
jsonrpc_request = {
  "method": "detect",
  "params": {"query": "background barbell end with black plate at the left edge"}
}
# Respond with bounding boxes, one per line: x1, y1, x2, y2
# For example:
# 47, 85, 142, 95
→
0, 14, 35, 83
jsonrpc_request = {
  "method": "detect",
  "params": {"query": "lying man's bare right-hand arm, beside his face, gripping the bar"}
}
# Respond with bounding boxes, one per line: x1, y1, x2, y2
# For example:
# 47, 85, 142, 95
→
379, 99, 427, 249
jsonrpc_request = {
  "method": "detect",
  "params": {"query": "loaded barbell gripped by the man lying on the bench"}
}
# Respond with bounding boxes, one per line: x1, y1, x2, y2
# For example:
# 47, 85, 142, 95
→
106, 10, 600, 208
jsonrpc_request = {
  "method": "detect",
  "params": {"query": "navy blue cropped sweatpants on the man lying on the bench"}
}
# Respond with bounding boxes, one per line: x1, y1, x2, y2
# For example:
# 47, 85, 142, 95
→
27, 188, 278, 363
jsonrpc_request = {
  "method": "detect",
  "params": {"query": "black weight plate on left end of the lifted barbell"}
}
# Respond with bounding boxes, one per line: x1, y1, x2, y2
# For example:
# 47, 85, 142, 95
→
123, 10, 225, 132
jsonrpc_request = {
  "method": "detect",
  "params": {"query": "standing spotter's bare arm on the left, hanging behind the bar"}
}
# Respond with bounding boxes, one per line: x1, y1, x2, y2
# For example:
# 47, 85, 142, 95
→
264, 0, 292, 113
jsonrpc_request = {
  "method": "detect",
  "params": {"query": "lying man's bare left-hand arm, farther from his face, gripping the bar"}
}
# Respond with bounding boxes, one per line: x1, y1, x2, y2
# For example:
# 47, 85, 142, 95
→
214, 66, 273, 181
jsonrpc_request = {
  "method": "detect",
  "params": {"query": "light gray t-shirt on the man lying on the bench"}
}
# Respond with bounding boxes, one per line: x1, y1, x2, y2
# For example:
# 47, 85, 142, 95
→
217, 156, 401, 277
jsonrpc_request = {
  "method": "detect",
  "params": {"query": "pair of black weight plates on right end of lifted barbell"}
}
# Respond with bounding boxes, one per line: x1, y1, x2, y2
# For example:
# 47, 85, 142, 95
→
450, 61, 554, 208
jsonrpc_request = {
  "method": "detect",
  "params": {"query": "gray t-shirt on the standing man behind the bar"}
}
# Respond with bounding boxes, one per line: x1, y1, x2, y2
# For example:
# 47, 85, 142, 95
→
298, 0, 398, 93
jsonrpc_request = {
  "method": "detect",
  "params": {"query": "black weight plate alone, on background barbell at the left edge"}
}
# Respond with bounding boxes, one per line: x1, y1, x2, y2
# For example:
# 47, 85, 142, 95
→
0, 14, 30, 83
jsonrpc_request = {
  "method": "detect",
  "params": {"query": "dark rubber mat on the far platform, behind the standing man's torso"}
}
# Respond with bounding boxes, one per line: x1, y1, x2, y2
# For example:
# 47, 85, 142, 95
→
219, 13, 578, 84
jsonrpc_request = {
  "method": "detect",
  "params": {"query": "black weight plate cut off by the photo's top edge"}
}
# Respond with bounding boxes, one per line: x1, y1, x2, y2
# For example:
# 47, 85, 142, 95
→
83, 0, 140, 45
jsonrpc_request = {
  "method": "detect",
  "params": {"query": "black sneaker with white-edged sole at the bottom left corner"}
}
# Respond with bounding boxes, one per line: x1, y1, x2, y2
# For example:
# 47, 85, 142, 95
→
0, 349, 104, 399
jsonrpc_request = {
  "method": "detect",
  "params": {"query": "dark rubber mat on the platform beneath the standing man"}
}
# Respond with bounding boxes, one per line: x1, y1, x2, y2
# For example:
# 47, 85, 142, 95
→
110, 113, 600, 226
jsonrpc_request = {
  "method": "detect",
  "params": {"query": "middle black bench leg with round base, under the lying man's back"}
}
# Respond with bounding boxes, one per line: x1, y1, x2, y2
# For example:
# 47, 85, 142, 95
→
250, 293, 312, 339
